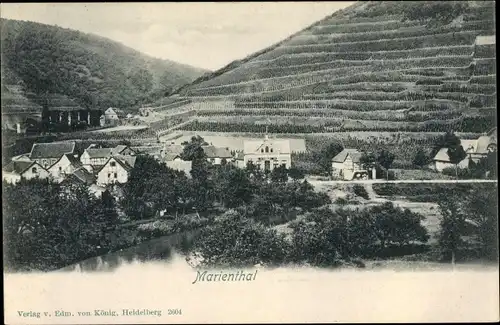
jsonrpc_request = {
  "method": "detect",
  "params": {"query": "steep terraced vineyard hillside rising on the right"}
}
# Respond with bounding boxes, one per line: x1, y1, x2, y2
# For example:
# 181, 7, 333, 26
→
169, 1, 496, 133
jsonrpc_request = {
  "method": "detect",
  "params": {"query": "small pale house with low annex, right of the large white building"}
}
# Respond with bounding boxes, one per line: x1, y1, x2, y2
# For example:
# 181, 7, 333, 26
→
332, 149, 376, 180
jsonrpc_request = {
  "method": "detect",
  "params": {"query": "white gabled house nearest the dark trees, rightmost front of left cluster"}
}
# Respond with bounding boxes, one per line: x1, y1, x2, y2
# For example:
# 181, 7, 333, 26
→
97, 156, 136, 185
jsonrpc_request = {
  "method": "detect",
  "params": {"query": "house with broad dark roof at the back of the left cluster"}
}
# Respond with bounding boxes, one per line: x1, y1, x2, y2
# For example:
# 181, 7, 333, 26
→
29, 141, 76, 169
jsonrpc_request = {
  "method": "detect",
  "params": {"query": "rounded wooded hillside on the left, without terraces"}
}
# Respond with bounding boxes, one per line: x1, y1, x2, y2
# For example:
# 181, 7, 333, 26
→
1, 19, 206, 112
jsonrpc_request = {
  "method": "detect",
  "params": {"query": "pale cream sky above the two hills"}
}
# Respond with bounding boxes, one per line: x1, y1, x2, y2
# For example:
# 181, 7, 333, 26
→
0, 1, 354, 70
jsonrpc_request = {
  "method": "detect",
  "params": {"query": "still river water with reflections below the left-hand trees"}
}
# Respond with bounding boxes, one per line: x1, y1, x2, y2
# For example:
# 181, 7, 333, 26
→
59, 231, 198, 272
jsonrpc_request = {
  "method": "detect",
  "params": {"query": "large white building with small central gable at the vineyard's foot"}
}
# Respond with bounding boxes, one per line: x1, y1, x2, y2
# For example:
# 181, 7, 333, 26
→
243, 135, 292, 171
